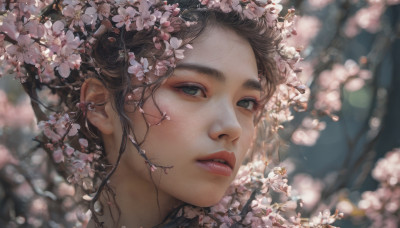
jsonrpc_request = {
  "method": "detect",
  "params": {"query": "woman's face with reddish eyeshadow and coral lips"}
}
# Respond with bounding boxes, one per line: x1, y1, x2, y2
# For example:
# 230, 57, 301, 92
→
115, 26, 261, 206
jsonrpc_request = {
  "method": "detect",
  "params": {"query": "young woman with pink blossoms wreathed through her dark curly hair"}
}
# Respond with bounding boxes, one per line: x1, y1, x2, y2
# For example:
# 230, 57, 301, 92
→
3, 0, 316, 227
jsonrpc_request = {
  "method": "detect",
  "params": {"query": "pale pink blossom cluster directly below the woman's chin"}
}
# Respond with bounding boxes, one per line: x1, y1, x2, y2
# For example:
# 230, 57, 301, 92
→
178, 161, 342, 228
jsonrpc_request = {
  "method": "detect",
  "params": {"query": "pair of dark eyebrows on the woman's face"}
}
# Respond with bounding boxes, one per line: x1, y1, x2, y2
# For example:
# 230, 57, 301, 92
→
175, 63, 262, 91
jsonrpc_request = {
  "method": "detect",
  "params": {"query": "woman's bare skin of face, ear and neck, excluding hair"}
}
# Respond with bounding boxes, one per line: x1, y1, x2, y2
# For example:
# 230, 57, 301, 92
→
81, 16, 274, 227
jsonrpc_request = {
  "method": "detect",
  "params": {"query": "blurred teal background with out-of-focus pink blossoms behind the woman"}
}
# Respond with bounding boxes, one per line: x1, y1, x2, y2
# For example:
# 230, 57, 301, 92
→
0, 0, 400, 228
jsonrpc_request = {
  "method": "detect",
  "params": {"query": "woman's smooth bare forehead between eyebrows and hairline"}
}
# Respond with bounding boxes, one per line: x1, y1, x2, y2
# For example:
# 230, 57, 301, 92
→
180, 25, 258, 79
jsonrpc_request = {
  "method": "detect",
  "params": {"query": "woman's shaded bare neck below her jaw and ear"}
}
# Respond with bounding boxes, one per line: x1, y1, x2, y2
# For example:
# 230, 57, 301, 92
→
90, 166, 180, 228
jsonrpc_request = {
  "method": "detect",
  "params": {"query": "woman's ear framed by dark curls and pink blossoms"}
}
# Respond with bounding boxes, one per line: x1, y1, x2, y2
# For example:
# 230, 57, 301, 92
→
80, 78, 116, 135
